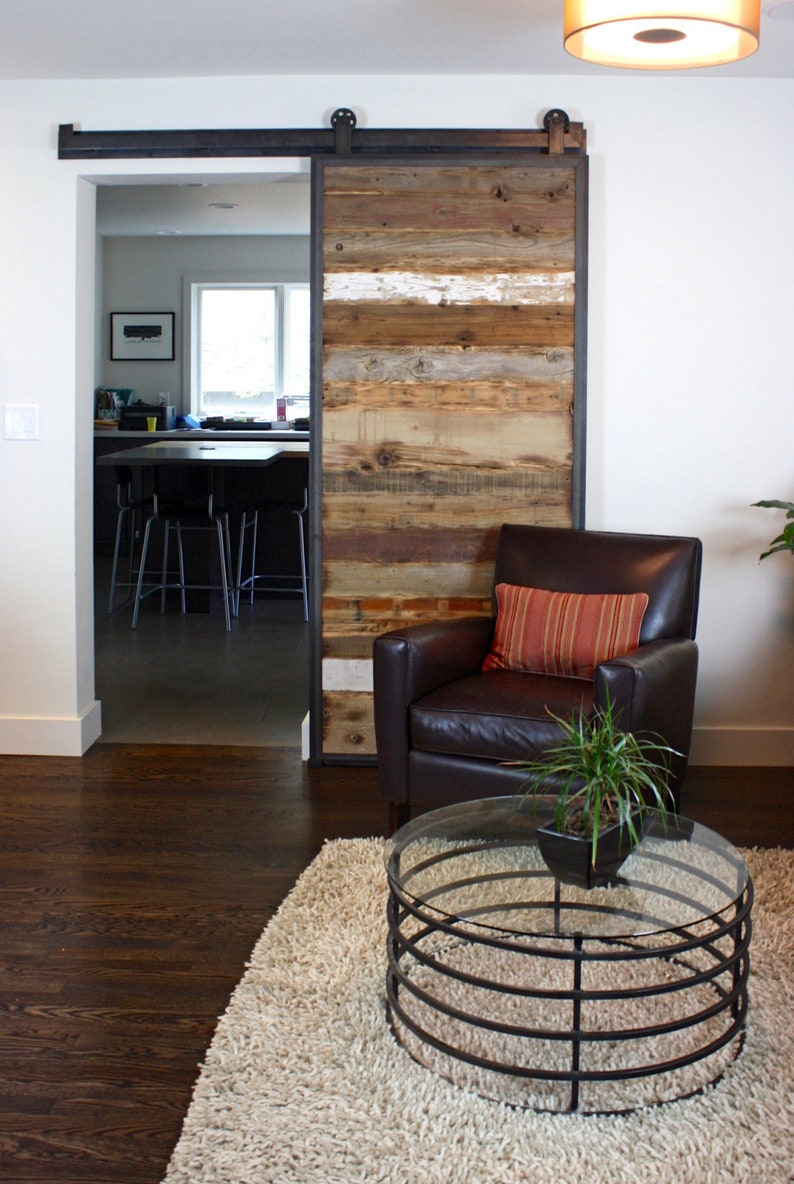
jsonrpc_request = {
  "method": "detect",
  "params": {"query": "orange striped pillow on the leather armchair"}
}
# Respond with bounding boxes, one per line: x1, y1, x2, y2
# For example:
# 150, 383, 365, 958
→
483, 584, 648, 678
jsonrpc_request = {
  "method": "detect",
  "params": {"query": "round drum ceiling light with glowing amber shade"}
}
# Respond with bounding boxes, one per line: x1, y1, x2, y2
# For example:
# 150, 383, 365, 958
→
564, 0, 761, 70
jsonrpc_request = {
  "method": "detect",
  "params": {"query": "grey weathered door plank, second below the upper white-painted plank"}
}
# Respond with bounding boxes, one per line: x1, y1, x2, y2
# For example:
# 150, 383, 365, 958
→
323, 346, 574, 384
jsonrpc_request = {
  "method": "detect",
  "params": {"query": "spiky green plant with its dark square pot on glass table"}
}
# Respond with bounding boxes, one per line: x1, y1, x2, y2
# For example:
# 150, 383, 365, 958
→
515, 696, 678, 888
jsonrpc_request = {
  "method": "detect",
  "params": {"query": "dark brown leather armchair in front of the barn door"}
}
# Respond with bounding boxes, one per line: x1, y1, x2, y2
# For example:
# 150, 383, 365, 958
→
373, 526, 702, 829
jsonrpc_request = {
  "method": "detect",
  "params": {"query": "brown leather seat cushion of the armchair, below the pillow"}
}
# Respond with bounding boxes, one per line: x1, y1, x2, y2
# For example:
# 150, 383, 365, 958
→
411, 670, 594, 760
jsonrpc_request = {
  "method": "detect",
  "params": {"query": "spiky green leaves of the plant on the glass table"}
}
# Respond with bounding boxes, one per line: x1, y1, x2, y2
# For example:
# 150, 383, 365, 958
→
514, 695, 680, 866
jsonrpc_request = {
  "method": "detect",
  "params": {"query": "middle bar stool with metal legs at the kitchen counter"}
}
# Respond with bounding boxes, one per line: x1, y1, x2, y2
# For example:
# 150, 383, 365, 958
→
133, 469, 237, 630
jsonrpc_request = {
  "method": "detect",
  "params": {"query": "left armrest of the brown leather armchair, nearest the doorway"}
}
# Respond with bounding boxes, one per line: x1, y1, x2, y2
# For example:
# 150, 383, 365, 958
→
373, 617, 495, 802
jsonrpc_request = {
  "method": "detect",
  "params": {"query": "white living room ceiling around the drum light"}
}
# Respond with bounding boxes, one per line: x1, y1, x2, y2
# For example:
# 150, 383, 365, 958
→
0, 0, 794, 78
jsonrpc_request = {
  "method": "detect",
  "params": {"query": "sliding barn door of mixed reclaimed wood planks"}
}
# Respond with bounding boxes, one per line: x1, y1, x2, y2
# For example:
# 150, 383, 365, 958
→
315, 154, 587, 759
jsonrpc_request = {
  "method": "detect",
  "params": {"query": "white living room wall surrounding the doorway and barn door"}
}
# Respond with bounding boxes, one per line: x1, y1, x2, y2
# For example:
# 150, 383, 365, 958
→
0, 72, 794, 765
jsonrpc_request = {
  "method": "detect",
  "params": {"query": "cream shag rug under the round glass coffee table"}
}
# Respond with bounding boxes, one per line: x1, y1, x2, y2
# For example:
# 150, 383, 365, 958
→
164, 839, 794, 1184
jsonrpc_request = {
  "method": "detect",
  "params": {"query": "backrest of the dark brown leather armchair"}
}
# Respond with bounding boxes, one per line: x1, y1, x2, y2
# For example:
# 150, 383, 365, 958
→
493, 525, 703, 645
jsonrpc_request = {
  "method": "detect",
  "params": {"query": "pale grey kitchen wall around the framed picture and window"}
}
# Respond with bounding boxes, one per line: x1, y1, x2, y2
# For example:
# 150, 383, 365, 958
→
96, 234, 310, 416
